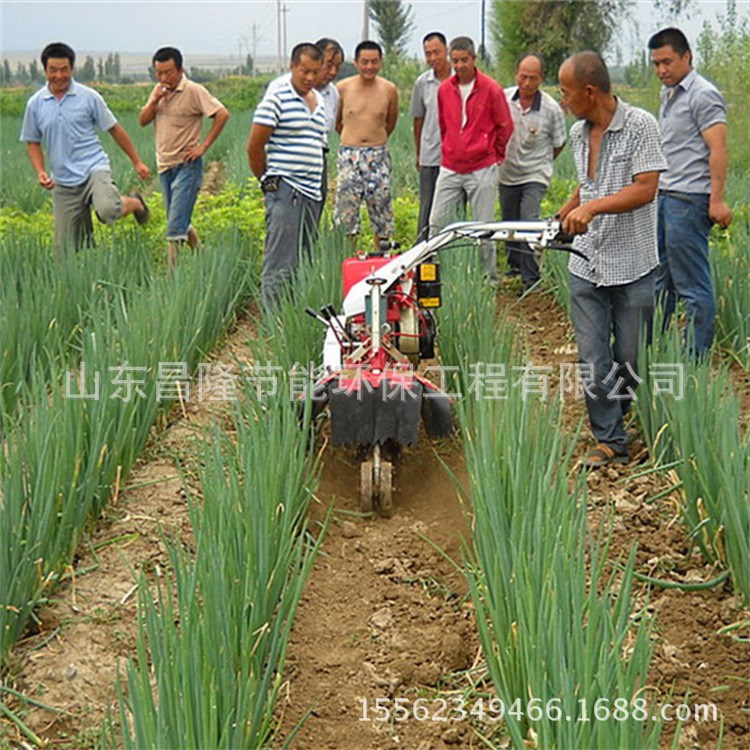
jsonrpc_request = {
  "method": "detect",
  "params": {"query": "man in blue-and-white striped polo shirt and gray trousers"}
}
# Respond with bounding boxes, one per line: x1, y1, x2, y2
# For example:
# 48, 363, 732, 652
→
247, 43, 326, 312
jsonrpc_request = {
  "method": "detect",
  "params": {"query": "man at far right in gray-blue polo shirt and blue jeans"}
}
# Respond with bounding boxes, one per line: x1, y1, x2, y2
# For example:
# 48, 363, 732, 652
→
648, 29, 732, 357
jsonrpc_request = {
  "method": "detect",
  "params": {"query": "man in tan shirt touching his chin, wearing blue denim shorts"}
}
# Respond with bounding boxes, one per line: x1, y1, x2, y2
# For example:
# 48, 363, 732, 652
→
138, 47, 229, 268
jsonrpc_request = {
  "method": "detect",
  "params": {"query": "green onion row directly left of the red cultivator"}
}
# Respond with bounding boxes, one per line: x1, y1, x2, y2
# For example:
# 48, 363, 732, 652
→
105, 234, 348, 749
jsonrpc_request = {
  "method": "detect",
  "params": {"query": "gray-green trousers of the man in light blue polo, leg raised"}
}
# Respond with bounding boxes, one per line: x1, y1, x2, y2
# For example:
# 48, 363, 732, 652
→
52, 169, 122, 251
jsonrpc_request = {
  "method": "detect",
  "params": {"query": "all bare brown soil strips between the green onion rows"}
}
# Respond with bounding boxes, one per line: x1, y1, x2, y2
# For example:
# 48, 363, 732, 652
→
0, 280, 750, 750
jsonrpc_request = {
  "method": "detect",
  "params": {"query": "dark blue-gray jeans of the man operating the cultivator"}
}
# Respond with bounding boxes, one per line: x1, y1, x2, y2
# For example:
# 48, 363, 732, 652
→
570, 270, 656, 454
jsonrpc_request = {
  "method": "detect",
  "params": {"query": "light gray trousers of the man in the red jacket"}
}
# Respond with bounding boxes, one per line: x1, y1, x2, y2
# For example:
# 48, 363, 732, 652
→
430, 164, 497, 283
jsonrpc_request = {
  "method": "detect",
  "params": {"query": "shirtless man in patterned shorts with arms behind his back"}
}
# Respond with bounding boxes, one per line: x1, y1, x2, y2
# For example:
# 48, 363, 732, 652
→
334, 41, 398, 248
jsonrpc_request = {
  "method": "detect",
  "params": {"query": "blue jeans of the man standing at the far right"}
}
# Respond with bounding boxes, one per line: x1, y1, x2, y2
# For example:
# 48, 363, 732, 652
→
656, 192, 716, 357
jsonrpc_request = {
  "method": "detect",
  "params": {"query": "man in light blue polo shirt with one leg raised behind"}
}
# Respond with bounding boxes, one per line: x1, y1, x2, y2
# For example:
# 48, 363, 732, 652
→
21, 42, 150, 251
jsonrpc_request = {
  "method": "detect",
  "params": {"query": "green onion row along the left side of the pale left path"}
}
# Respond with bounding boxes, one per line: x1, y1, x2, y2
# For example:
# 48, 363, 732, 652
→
0, 238, 257, 661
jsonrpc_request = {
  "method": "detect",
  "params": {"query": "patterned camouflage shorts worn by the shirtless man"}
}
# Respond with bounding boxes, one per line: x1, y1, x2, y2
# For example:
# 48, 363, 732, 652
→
333, 146, 394, 239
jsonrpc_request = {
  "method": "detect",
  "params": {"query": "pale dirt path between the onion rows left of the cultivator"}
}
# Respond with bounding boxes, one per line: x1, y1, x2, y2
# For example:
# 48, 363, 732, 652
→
0, 321, 254, 750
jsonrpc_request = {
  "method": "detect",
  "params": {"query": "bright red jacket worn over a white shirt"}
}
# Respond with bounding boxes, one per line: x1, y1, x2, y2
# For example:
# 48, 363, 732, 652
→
438, 70, 513, 174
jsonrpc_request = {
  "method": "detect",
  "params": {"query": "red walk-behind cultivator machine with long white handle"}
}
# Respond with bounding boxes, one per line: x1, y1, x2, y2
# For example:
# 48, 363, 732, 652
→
307, 221, 570, 516
